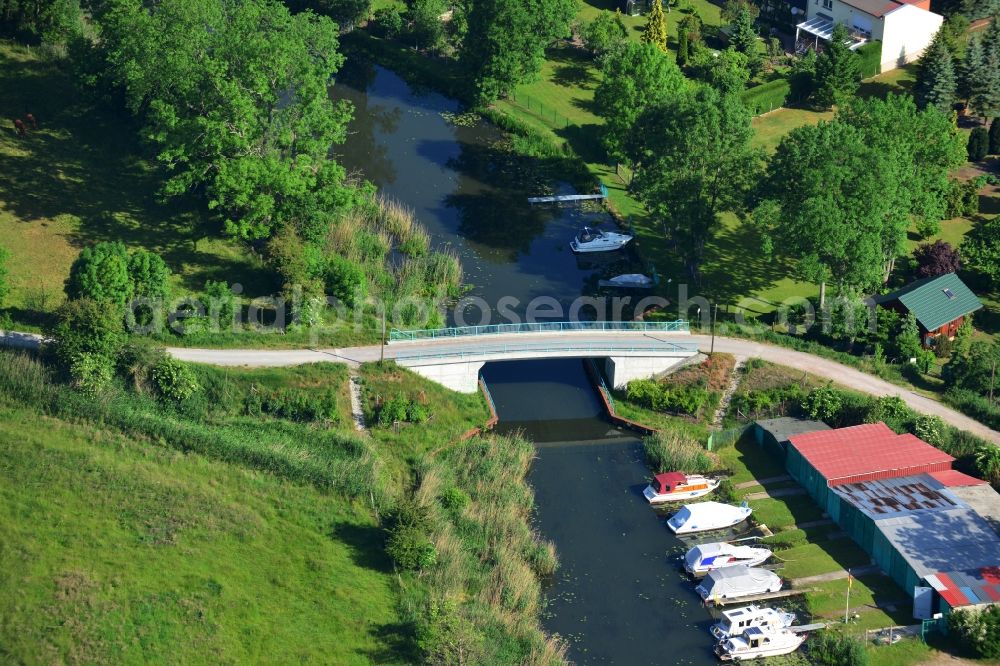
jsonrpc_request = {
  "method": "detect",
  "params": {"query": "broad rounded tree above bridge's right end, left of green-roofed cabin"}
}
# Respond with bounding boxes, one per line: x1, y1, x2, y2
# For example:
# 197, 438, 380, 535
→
755, 122, 889, 305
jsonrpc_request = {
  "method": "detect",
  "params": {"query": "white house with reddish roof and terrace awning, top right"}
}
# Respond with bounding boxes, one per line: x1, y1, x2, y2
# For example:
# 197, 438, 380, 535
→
795, 0, 944, 72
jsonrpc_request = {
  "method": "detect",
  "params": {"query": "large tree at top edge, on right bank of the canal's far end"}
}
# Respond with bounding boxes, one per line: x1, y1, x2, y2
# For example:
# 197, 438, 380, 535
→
459, 0, 576, 103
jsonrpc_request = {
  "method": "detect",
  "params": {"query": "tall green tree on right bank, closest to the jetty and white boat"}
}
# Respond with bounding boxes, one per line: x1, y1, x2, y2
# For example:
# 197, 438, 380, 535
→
633, 86, 763, 281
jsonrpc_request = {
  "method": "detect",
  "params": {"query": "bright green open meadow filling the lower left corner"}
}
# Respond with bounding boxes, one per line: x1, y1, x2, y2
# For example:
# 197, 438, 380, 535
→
0, 396, 410, 664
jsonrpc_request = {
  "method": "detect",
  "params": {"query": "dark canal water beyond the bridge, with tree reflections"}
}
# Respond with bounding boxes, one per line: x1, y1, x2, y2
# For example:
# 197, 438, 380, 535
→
331, 63, 643, 325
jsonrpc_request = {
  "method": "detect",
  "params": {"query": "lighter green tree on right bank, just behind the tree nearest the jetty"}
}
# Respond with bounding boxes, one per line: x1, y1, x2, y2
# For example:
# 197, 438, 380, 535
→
594, 42, 687, 160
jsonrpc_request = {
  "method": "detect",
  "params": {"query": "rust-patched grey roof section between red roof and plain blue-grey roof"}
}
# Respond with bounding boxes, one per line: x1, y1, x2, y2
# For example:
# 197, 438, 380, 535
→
833, 474, 965, 520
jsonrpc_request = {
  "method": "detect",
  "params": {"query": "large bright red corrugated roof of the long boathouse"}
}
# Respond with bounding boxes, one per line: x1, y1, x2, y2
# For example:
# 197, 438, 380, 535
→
788, 423, 955, 487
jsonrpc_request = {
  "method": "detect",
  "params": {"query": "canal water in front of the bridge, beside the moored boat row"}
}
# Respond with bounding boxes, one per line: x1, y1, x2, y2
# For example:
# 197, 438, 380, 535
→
483, 359, 713, 664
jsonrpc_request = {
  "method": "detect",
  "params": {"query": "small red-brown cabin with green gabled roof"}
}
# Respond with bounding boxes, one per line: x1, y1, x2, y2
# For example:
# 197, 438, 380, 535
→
875, 273, 983, 347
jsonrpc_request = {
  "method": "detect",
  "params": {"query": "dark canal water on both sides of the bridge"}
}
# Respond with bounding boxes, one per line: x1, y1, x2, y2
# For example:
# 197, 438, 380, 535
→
333, 64, 713, 664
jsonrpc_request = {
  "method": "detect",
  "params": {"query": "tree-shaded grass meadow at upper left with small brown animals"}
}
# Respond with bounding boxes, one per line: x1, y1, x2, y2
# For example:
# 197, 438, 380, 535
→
0, 42, 276, 324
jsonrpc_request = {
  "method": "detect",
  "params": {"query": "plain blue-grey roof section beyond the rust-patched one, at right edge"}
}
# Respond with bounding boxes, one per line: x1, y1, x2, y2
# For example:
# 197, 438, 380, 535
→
874, 507, 1000, 580
